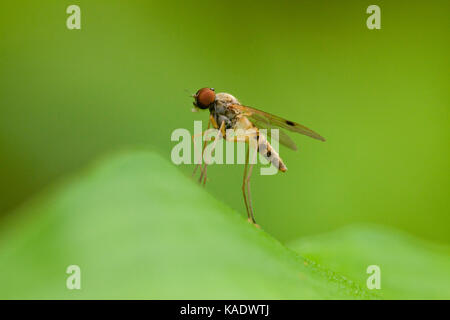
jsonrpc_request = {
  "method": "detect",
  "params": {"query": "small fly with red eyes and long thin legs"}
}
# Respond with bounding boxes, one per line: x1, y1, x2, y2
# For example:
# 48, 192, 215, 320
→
192, 88, 325, 227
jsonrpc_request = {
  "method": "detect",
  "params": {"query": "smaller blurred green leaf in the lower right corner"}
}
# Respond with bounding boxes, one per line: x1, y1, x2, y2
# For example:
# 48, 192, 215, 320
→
289, 225, 450, 299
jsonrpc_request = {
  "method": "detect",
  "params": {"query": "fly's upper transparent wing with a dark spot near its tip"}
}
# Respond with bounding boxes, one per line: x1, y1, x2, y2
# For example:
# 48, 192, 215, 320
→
229, 104, 325, 141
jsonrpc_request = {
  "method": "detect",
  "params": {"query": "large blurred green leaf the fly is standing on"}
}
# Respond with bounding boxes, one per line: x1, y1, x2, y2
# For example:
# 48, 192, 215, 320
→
0, 151, 376, 299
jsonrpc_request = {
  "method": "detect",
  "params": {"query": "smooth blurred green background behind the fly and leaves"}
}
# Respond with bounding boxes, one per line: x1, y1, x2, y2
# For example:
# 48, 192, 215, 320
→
0, 0, 450, 243
